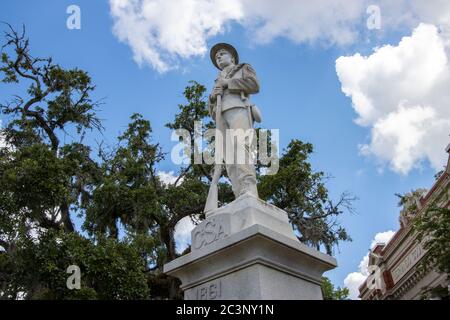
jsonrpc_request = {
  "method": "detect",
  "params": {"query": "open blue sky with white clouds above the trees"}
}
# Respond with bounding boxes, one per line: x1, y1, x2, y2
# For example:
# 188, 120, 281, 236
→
0, 0, 450, 300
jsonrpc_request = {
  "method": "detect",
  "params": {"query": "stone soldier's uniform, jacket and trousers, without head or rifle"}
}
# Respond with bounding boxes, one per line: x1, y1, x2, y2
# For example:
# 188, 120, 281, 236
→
209, 63, 259, 197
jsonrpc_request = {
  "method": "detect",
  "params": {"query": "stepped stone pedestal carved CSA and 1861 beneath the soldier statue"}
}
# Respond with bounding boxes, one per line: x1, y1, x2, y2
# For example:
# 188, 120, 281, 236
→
164, 195, 336, 300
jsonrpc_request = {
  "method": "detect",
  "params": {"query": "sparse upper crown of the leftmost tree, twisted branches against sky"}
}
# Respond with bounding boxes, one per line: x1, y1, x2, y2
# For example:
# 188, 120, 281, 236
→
0, 26, 101, 152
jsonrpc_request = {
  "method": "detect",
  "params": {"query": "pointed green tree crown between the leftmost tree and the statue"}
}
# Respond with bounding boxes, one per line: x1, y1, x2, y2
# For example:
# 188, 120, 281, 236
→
84, 114, 163, 238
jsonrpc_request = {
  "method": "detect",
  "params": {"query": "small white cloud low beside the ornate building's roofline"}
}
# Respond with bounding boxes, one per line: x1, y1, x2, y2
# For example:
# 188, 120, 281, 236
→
344, 230, 395, 300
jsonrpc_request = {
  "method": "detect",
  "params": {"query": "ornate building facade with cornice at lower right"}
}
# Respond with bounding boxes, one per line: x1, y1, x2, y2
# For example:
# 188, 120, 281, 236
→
359, 144, 450, 300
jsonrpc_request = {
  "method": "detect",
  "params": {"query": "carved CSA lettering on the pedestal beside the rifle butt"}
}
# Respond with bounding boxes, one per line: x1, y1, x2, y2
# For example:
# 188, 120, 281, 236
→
192, 218, 228, 249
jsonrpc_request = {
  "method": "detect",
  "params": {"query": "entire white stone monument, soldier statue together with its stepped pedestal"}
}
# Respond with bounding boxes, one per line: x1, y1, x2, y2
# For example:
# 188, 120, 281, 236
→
164, 43, 337, 300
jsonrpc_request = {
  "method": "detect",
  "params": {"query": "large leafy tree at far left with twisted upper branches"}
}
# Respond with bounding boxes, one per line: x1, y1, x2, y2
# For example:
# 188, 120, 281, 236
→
0, 26, 148, 299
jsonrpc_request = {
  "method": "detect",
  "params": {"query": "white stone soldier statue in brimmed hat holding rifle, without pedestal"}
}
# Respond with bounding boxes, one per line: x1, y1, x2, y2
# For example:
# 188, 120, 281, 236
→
205, 43, 261, 213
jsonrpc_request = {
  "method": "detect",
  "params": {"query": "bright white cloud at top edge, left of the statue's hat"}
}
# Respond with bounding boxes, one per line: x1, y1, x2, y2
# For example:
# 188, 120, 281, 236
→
109, 0, 242, 72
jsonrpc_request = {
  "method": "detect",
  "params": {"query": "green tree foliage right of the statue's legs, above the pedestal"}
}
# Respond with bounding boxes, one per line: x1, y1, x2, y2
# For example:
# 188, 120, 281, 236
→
258, 140, 355, 254
